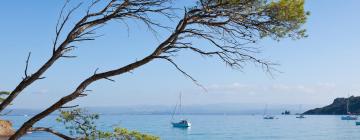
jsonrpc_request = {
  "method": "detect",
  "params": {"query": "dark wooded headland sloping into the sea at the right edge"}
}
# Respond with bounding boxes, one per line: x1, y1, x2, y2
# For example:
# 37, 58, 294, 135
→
303, 96, 360, 115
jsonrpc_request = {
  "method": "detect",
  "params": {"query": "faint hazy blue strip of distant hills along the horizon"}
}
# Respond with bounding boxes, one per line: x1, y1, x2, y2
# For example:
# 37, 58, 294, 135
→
5, 103, 322, 116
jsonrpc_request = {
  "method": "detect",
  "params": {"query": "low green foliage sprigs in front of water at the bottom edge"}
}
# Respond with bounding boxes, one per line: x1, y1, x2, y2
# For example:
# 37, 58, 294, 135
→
56, 108, 160, 140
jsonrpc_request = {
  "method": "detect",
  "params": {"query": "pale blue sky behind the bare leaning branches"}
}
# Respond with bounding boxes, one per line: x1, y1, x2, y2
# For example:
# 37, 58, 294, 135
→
0, 0, 360, 108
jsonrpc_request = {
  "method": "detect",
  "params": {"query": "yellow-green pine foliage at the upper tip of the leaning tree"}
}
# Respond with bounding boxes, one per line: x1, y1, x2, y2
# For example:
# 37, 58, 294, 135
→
197, 0, 309, 40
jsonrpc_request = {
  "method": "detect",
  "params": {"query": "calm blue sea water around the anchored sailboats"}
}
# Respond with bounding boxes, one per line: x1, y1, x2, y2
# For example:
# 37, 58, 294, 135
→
6, 115, 360, 140
